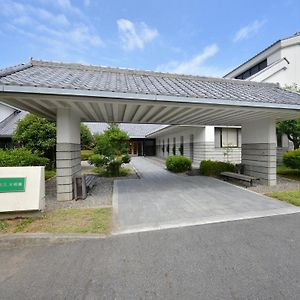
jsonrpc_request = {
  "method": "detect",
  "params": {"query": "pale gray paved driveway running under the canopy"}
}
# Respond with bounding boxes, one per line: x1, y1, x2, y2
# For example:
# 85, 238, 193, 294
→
113, 157, 299, 233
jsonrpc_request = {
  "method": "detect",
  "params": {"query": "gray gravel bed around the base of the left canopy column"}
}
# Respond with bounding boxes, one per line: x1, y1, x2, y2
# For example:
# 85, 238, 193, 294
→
45, 161, 138, 211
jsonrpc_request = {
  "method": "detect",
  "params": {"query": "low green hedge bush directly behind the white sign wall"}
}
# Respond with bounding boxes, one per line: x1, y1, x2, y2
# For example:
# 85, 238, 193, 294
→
0, 148, 49, 167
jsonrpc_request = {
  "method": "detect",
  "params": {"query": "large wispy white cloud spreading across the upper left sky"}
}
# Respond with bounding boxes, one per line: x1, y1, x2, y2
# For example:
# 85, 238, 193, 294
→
0, 0, 104, 59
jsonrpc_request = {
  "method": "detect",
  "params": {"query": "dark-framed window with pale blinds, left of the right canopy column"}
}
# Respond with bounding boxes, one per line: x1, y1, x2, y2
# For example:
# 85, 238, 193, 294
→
215, 127, 241, 148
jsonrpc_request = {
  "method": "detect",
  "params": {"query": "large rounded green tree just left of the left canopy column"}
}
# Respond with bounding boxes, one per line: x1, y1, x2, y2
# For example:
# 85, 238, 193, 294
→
13, 114, 56, 162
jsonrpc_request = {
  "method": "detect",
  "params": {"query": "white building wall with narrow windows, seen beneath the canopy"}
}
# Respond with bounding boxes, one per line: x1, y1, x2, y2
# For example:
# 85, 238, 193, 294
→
155, 126, 241, 167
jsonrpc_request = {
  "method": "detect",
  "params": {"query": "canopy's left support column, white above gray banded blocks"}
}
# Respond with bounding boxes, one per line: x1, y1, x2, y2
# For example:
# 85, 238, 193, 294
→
56, 108, 81, 201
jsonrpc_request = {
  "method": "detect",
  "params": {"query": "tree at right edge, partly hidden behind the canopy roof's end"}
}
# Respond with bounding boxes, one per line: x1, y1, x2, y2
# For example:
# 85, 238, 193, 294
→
276, 84, 300, 149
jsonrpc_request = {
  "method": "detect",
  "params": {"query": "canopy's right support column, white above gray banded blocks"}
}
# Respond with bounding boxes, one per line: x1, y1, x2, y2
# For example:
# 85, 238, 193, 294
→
242, 119, 276, 185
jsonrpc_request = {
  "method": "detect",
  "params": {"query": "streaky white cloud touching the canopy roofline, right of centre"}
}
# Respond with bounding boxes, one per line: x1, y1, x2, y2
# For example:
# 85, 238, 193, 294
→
157, 44, 226, 76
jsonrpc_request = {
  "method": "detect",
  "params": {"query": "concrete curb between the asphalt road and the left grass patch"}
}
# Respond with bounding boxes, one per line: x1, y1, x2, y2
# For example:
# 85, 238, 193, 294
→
0, 233, 108, 249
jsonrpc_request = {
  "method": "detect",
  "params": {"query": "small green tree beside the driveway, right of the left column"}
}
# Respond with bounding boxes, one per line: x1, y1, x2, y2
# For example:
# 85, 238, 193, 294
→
90, 124, 130, 176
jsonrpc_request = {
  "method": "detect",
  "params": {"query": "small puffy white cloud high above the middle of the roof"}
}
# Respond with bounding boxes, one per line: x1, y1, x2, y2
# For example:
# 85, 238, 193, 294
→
117, 19, 158, 50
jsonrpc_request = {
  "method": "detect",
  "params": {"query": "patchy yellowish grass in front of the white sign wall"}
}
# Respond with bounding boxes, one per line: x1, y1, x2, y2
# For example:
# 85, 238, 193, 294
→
0, 208, 112, 234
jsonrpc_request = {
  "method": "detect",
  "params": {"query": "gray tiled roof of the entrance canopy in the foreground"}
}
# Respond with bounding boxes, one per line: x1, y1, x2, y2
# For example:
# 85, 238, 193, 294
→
0, 60, 300, 105
